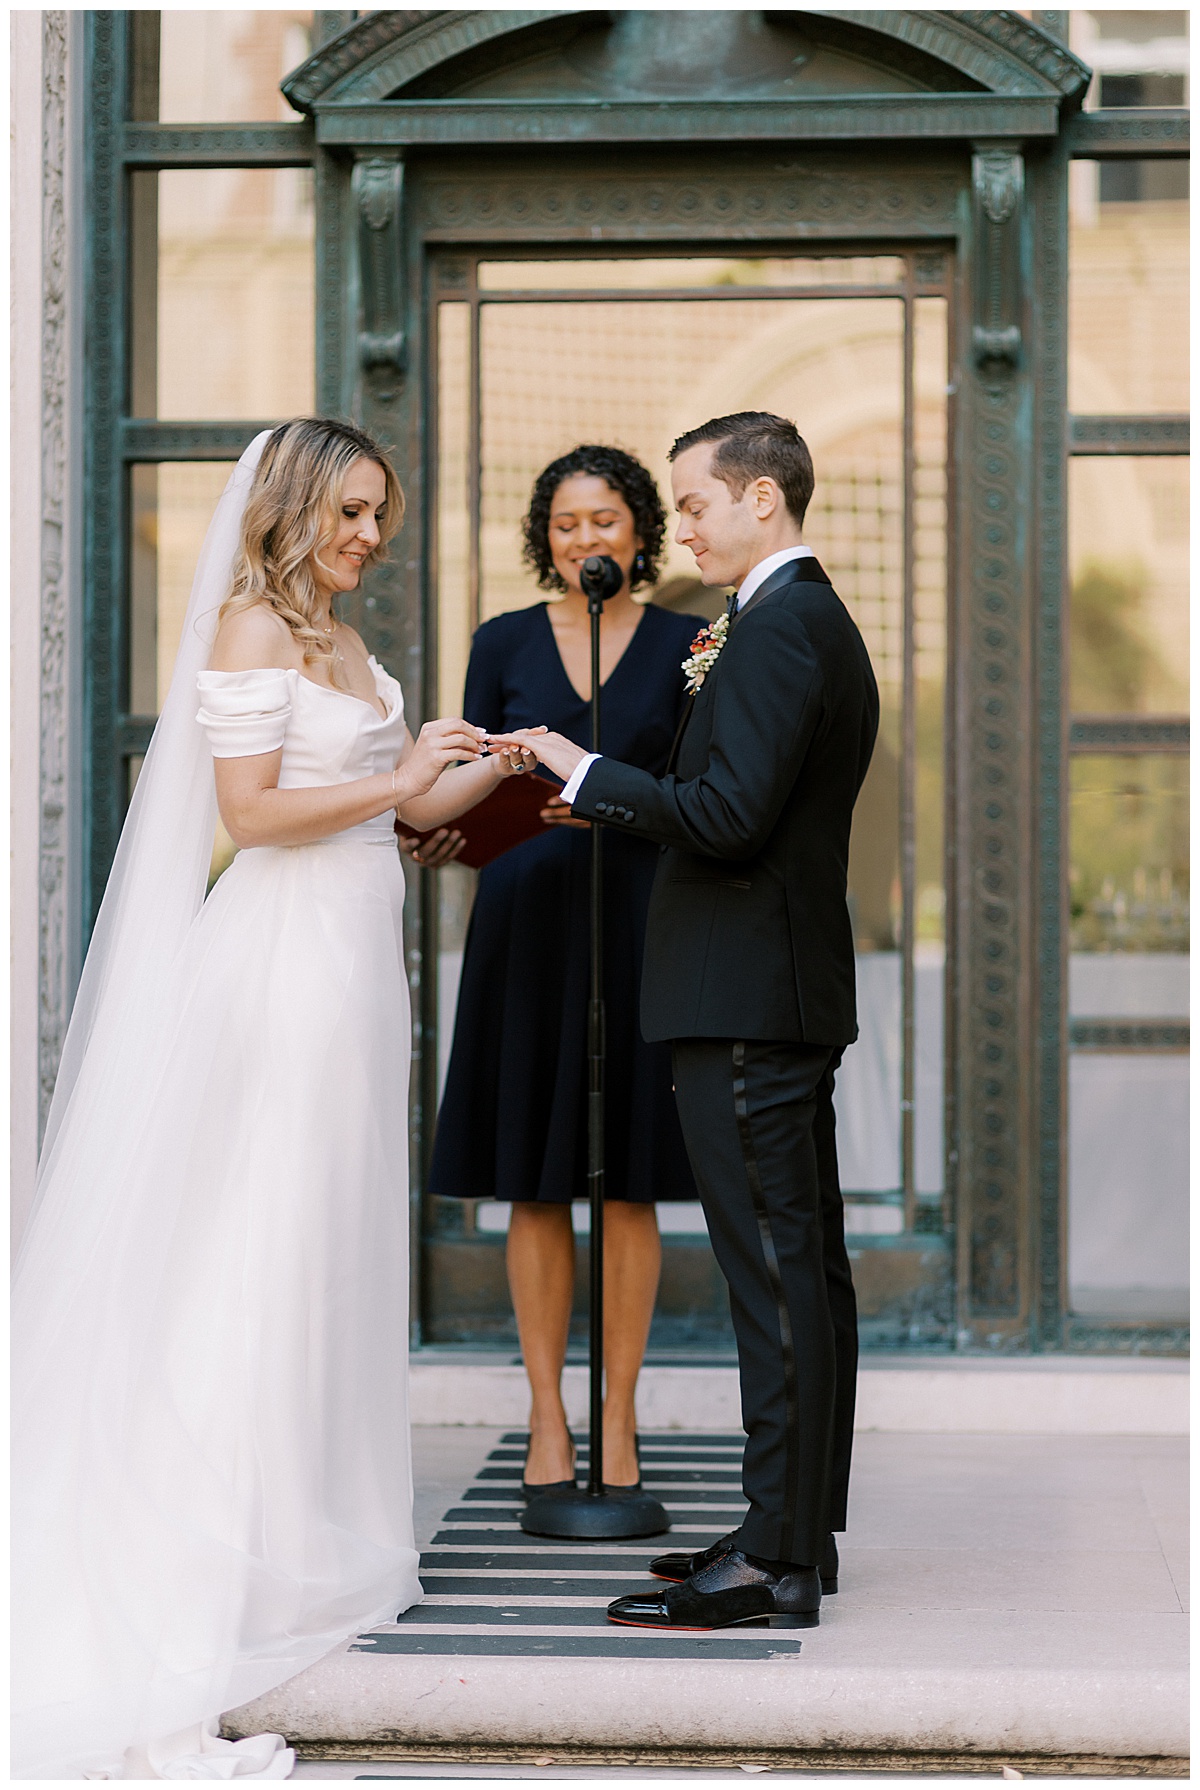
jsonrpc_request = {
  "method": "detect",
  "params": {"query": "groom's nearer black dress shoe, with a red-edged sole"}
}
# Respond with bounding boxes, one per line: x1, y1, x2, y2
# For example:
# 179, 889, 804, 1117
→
609, 1548, 820, 1629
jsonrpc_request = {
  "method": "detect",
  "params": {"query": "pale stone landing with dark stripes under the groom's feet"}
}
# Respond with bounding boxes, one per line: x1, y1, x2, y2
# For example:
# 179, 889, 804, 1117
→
226, 1428, 1187, 1776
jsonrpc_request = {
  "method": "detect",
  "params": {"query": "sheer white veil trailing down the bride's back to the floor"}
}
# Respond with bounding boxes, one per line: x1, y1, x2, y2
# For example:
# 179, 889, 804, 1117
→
13, 431, 302, 1777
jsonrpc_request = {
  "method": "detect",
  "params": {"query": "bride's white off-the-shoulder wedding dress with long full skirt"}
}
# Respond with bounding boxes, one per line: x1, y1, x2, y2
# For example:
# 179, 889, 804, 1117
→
13, 436, 421, 1777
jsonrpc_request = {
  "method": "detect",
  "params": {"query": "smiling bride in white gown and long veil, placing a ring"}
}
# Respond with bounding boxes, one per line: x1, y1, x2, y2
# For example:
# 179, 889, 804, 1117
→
13, 419, 530, 1777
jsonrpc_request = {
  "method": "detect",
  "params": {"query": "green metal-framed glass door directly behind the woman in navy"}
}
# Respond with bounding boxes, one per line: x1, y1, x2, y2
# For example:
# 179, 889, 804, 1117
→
423, 243, 953, 1351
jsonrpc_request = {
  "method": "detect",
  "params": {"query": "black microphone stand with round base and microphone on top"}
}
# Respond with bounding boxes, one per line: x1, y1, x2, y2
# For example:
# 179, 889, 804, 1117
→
521, 553, 670, 1541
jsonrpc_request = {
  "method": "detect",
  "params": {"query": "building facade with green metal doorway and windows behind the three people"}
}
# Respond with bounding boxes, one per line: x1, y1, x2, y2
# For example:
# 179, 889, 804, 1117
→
13, 11, 1189, 1359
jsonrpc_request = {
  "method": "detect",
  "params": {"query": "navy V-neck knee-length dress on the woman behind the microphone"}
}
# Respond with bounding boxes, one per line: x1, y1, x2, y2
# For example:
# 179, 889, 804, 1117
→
430, 603, 704, 1203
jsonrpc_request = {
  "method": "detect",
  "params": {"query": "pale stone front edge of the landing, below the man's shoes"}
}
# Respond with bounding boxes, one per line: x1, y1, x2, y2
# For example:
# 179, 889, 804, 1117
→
224, 1652, 1189, 1761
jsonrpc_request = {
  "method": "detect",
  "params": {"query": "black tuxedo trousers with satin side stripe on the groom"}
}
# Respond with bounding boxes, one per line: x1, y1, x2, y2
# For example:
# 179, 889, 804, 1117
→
672, 1038, 858, 1566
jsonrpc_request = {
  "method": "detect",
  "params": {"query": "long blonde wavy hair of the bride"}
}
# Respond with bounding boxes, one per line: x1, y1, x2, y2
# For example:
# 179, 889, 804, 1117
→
219, 417, 405, 680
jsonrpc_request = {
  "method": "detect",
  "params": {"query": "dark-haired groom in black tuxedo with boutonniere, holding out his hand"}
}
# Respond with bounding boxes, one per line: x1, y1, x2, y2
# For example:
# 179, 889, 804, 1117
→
501, 412, 879, 1629
